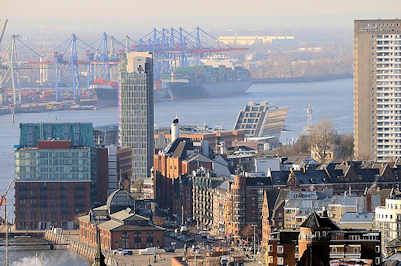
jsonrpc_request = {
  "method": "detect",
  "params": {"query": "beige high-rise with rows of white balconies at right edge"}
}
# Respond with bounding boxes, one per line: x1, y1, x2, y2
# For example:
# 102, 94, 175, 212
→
354, 19, 401, 161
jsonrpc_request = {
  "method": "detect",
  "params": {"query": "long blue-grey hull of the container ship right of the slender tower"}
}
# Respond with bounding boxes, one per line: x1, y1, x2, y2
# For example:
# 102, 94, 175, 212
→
168, 80, 252, 99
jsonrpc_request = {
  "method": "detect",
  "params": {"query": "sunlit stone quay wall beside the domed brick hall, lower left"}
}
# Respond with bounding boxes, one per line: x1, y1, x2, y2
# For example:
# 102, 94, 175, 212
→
44, 230, 118, 265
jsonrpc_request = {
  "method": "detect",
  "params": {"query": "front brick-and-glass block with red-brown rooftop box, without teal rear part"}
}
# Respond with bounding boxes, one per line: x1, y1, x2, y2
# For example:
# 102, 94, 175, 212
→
15, 141, 92, 229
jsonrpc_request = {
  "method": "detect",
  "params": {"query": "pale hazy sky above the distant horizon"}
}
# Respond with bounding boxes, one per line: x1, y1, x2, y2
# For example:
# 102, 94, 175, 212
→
0, 0, 401, 32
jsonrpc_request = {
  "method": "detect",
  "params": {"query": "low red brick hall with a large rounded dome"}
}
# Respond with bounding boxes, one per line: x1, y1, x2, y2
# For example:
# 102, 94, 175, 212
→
78, 190, 164, 249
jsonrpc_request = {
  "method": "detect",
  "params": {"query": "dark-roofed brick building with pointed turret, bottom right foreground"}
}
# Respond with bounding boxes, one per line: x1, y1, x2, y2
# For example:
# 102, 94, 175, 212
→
266, 212, 381, 266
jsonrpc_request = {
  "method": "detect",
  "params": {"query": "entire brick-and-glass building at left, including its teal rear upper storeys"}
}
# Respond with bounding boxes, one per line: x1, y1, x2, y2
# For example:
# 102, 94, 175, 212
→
14, 123, 107, 230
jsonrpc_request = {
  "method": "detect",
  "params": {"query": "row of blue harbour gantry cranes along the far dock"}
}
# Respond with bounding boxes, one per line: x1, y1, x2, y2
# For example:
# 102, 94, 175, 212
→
0, 27, 247, 104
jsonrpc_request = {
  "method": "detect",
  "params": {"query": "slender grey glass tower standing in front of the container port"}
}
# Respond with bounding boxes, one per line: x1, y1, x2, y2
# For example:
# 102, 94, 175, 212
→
119, 52, 154, 184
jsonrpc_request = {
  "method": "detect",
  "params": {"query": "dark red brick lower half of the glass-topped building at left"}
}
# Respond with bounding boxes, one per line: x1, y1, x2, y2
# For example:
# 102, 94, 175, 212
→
15, 181, 91, 230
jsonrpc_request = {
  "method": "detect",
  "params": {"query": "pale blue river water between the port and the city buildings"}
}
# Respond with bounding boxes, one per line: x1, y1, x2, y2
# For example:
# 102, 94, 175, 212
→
0, 79, 353, 265
